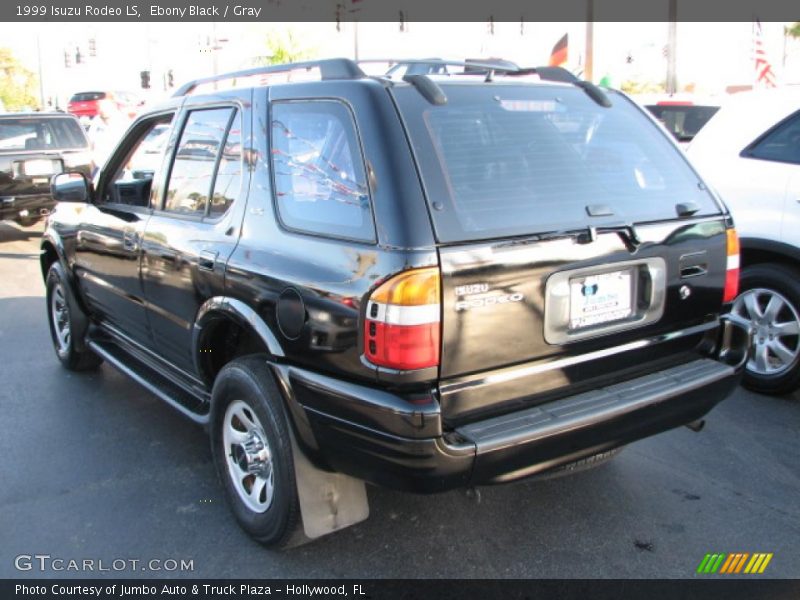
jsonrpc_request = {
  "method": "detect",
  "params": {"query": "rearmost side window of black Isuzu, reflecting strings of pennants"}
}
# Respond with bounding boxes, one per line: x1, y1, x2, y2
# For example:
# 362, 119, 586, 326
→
271, 100, 375, 241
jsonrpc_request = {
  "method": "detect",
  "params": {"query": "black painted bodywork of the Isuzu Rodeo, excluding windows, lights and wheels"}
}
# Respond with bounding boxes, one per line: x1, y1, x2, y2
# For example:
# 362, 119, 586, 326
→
42, 63, 748, 500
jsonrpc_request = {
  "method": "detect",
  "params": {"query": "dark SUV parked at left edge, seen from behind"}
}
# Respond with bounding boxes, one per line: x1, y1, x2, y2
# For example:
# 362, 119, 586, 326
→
0, 113, 90, 226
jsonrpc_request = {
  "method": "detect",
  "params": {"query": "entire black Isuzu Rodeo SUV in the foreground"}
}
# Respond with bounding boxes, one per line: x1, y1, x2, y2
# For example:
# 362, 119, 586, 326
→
41, 59, 749, 545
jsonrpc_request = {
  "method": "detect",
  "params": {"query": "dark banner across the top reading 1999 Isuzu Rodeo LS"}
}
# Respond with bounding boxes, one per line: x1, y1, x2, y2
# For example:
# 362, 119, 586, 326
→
0, 0, 800, 22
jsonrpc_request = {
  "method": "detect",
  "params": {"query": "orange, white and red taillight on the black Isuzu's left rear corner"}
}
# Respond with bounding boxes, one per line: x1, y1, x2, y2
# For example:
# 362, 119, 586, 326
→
364, 267, 441, 371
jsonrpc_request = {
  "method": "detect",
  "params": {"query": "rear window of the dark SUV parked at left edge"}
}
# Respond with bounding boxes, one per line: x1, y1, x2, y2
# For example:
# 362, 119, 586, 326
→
0, 117, 89, 152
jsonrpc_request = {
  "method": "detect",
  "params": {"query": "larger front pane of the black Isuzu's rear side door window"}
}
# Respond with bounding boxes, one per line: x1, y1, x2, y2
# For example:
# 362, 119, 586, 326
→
164, 108, 234, 216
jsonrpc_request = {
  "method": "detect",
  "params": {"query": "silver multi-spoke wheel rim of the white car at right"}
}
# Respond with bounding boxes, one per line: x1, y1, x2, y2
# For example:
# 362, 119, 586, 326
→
733, 288, 800, 376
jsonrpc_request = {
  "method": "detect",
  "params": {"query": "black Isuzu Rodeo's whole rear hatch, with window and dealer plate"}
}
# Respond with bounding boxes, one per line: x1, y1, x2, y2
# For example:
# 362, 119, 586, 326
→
392, 80, 727, 423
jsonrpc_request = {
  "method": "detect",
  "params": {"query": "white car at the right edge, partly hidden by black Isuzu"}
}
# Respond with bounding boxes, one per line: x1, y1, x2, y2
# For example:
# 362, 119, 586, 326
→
687, 87, 800, 394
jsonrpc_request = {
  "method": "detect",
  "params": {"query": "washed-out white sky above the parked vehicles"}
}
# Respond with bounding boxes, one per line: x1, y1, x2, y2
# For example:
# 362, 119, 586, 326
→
0, 21, 800, 106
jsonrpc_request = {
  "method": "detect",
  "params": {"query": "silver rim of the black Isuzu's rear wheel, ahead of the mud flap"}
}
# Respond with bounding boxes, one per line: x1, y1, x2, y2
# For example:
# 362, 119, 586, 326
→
222, 400, 275, 513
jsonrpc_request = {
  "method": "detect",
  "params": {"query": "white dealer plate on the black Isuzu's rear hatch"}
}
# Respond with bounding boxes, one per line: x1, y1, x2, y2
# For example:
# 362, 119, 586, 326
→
569, 269, 633, 330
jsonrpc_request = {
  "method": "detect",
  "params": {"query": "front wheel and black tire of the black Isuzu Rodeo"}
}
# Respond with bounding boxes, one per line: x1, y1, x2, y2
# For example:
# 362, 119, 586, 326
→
46, 262, 103, 371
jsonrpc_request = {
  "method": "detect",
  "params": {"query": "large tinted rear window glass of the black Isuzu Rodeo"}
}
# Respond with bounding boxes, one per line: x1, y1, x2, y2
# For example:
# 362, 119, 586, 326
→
395, 83, 719, 242
